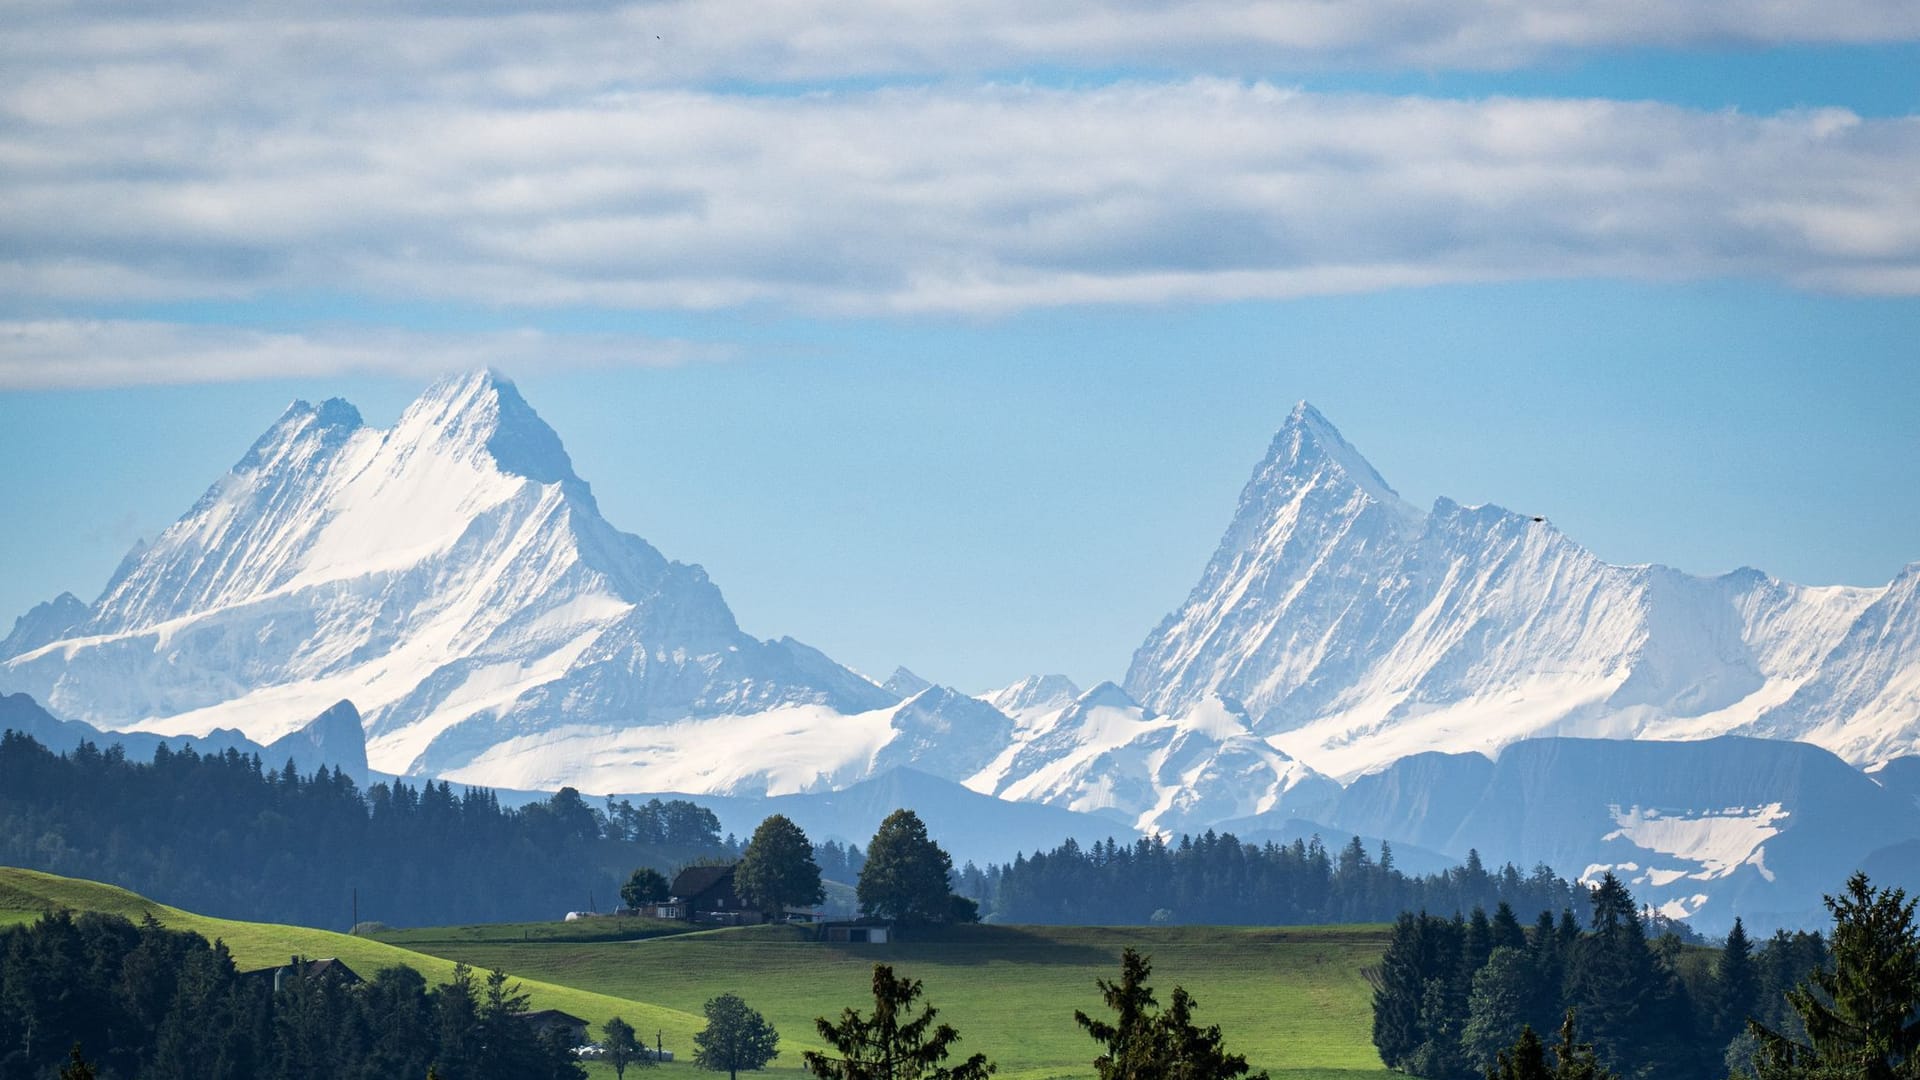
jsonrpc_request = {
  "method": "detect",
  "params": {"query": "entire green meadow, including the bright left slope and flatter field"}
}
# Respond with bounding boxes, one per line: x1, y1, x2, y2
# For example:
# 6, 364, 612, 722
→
0, 869, 1388, 1080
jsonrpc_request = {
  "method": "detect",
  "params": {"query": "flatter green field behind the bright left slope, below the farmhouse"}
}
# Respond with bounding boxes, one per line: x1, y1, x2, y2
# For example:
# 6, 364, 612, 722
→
378, 914, 1386, 1080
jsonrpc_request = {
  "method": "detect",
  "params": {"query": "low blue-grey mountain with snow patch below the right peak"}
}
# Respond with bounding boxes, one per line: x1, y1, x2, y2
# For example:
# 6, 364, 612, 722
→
1329, 736, 1920, 930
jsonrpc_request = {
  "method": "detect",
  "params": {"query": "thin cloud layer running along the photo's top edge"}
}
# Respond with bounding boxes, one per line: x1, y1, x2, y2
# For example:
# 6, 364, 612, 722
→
15, 0, 1920, 99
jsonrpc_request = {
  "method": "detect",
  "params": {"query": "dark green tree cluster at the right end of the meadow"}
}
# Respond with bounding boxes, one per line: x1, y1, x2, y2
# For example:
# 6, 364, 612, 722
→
1373, 874, 1835, 1080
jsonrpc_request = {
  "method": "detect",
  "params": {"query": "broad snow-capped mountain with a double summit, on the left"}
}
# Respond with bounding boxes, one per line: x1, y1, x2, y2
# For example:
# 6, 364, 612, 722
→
0, 365, 899, 788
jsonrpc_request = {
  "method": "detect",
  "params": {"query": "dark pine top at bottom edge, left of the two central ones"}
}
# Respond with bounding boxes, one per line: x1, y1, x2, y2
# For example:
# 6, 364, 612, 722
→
801, 957, 995, 1080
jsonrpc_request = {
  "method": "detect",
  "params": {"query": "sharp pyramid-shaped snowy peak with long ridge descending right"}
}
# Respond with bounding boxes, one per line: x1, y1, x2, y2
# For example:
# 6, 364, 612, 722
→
1125, 404, 1920, 778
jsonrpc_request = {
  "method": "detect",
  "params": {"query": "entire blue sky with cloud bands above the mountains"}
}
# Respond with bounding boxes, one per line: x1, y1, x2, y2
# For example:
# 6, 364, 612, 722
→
0, 0, 1920, 690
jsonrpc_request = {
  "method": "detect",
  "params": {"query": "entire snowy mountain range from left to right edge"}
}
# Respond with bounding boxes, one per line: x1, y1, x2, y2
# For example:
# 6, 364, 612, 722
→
0, 373, 1920, 915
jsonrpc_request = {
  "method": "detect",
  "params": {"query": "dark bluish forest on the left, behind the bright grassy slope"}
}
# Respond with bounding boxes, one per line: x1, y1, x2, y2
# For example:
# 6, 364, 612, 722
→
0, 732, 733, 928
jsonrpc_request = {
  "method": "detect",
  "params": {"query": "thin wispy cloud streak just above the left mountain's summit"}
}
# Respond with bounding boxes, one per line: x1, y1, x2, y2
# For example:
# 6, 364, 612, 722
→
0, 319, 728, 390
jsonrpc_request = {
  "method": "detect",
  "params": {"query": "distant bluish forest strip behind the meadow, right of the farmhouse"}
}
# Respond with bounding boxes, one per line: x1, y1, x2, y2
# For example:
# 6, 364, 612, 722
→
960, 830, 1584, 926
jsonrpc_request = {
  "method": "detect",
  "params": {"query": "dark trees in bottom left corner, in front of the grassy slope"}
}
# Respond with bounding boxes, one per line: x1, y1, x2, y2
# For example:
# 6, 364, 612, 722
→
0, 913, 586, 1080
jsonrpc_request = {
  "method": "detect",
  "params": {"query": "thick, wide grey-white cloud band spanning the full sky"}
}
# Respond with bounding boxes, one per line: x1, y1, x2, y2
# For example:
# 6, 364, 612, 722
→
0, 79, 1920, 313
